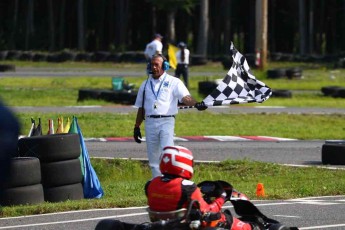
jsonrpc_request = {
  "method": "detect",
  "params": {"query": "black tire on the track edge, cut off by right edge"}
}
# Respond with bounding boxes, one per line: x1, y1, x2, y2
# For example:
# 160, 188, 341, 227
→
321, 142, 345, 165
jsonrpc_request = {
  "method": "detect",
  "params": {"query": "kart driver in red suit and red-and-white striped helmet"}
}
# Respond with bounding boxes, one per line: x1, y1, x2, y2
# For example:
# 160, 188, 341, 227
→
145, 146, 260, 230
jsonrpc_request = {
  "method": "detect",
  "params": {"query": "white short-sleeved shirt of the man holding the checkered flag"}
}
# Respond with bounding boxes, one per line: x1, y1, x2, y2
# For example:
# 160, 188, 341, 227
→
134, 72, 190, 116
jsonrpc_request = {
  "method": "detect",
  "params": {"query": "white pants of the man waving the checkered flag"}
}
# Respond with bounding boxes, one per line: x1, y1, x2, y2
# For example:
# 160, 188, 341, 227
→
145, 117, 175, 178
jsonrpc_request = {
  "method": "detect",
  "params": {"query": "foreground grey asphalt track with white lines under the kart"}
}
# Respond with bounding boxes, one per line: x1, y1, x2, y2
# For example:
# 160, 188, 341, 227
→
0, 196, 345, 230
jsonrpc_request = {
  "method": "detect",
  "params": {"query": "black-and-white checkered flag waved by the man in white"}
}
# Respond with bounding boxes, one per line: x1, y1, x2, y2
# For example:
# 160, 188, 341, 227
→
203, 43, 272, 106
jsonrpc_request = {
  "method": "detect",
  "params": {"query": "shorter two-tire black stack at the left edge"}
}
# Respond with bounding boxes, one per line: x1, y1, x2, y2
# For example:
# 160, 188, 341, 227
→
0, 157, 44, 206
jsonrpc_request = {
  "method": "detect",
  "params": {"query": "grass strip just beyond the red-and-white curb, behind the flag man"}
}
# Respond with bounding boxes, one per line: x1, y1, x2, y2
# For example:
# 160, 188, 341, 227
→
17, 111, 345, 140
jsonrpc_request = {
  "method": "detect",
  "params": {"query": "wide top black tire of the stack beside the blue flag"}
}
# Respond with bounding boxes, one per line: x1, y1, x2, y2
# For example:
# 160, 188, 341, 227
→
18, 133, 81, 164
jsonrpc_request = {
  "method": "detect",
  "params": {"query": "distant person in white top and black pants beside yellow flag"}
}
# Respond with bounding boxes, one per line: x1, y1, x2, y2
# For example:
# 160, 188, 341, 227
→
175, 42, 190, 88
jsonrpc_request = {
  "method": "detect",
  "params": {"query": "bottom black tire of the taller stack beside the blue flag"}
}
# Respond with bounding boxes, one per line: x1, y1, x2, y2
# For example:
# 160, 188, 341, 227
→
43, 183, 84, 202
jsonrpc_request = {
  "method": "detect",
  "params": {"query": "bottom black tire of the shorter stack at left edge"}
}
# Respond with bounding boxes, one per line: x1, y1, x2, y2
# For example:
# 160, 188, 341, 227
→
0, 184, 44, 206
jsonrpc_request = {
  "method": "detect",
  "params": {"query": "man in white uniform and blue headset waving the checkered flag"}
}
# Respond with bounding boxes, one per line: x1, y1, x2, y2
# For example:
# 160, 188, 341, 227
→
133, 54, 207, 177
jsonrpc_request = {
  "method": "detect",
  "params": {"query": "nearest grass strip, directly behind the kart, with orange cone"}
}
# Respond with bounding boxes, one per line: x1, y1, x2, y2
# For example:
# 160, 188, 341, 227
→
0, 159, 345, 217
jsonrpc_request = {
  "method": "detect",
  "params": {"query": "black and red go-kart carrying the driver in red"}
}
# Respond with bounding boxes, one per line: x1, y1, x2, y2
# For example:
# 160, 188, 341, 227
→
96, 180, 298, 230
